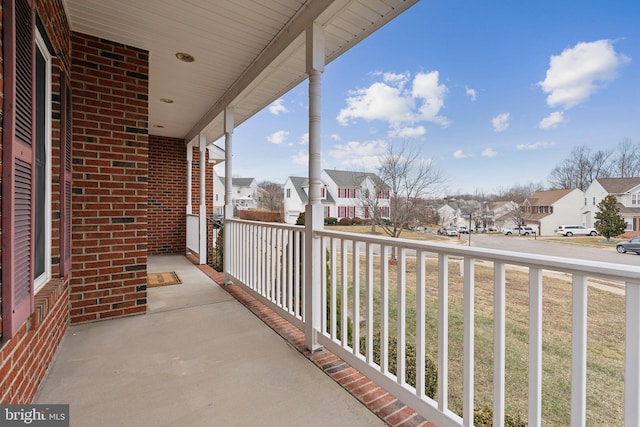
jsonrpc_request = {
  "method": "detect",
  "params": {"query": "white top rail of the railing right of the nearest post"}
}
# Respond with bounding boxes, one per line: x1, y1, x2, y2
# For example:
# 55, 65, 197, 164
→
316, 230, 640, 286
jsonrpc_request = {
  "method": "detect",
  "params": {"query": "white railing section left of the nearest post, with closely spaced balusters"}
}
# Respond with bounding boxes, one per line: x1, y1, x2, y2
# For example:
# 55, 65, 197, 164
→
224, 219, 305, 329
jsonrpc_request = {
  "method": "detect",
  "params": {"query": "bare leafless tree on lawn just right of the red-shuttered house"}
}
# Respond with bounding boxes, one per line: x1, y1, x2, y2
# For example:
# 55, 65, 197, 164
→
374, 143, 444, 237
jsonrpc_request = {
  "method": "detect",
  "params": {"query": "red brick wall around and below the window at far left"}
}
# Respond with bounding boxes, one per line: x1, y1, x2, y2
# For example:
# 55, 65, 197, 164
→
0, 0, 70, 404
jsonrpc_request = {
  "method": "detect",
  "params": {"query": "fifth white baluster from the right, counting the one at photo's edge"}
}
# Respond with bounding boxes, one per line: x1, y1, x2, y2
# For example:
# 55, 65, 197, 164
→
462, 257, 475, 426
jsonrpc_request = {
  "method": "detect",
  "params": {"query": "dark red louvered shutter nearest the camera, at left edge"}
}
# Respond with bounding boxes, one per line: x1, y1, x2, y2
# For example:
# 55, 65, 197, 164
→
2, 0, 35, 340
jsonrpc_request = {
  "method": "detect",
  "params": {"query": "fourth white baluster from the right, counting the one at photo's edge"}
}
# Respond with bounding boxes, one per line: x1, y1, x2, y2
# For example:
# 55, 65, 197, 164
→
493, 262, 506, 427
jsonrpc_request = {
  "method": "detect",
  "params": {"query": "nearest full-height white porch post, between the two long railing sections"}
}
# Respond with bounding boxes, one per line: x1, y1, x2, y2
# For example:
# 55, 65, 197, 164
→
304, 23, 324, 351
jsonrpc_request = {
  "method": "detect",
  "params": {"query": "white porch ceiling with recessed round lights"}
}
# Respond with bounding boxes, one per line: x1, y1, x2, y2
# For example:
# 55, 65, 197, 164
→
65, 0, 418, 142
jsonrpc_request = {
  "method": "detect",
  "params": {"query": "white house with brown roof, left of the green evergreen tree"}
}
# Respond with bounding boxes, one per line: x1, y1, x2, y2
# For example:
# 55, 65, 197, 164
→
521, 188, 585, 235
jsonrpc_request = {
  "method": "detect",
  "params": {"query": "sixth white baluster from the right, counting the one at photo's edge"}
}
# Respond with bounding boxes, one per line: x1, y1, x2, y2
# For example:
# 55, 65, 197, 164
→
438, 253, 449, 412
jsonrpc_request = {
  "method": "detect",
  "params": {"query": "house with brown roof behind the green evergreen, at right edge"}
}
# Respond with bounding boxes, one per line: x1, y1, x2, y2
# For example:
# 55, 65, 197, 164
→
581, 178, 640, 237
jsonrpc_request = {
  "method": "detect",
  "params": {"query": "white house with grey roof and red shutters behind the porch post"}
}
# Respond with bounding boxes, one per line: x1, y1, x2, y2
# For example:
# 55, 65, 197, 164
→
284, 170, 391, 224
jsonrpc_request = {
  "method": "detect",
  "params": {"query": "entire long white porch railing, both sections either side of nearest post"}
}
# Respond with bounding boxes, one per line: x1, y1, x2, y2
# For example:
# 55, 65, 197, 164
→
225, 221, 640, 426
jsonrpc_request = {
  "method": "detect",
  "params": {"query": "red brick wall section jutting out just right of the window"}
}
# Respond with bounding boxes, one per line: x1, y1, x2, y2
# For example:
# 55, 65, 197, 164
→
70, 33, 149, 323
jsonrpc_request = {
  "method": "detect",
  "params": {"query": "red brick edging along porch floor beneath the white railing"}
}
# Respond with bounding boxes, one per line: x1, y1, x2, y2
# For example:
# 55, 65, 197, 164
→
187, 257, 435, 427
